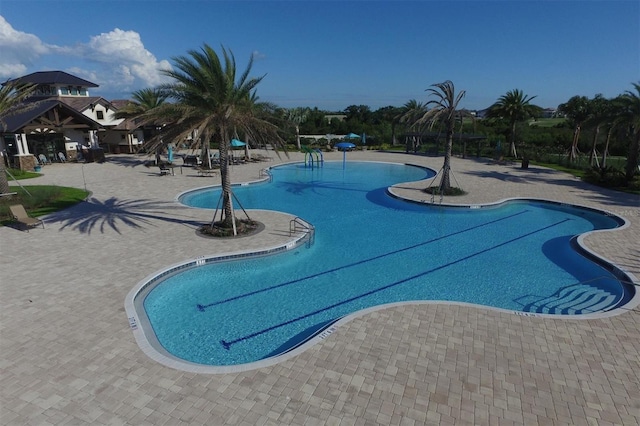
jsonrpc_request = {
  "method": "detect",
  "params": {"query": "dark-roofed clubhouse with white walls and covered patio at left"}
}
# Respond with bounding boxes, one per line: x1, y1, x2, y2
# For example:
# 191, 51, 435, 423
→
0, 71, 143, 170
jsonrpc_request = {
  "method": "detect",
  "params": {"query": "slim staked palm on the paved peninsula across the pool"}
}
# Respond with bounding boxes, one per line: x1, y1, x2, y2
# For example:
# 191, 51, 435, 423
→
418, 80, 466, 193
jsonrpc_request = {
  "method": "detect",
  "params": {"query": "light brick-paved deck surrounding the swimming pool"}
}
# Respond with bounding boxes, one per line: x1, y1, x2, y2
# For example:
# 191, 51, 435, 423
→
0, 151, 640, 425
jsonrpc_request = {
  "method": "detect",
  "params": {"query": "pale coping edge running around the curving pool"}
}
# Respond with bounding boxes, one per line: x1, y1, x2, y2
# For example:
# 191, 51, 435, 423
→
125, 161, 640, 374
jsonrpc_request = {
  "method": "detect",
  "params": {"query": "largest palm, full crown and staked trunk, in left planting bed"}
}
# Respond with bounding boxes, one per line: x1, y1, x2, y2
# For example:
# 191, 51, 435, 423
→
146, 44, 282, 234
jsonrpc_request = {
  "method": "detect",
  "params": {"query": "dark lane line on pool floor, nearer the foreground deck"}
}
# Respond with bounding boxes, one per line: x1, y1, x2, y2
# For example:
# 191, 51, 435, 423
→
220, 218, 572, 350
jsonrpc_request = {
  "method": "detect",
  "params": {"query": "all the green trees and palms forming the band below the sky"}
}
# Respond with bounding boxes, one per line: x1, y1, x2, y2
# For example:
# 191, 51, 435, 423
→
0, 44, 640, 205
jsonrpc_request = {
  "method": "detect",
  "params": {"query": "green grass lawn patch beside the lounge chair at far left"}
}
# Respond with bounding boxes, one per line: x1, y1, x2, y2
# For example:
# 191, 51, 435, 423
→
0, 186, 89, 226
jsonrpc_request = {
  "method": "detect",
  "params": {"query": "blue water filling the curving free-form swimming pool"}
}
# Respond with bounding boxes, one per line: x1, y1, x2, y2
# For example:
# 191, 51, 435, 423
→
139, 162, 625, 366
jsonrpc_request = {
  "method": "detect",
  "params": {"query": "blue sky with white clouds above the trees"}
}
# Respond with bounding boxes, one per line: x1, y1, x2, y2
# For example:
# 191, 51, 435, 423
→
0, 0, 640, 111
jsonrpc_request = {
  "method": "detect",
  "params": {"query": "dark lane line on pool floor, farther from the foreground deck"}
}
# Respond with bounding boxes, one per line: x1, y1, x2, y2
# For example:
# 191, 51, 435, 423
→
196, 210, 530, 312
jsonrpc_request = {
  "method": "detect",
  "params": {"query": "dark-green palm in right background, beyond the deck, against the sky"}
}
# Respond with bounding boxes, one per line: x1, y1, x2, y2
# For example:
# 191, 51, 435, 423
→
487, 89, 542, 158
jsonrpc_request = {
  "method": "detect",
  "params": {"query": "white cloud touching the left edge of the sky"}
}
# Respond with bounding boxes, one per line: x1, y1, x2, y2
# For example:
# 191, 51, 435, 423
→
0, 16, 52, 78
